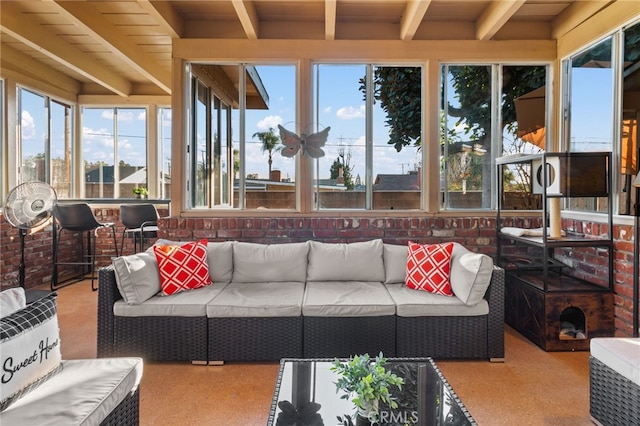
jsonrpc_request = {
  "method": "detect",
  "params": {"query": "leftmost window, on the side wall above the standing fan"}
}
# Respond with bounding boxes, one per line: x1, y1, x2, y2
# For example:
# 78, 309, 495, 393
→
18, 88, 73, 198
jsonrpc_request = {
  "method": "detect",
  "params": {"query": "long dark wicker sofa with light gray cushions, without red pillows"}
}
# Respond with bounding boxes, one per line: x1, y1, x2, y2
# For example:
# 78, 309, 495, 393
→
98, 239, 504, 363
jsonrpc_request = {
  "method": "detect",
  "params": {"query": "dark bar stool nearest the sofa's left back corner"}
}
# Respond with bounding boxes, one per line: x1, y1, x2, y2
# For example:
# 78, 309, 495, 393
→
120, 204, 158, 254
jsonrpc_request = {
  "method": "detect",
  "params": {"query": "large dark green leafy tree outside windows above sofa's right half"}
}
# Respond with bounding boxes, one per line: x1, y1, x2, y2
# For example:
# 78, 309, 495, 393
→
370, 66, 546, 207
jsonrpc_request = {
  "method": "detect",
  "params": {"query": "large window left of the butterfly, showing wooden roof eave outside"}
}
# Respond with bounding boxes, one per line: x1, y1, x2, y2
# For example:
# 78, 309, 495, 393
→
189, 64, 296, 209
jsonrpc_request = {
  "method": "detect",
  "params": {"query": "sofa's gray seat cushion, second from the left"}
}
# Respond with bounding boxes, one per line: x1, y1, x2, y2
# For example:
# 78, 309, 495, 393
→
206, 281, 304, 318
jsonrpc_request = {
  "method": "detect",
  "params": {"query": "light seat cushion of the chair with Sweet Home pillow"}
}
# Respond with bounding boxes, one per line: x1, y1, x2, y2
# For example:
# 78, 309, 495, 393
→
1, 358, 142, 426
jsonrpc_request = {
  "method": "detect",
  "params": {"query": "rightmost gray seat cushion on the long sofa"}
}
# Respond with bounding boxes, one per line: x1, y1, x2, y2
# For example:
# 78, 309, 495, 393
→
386, 284, 489, 317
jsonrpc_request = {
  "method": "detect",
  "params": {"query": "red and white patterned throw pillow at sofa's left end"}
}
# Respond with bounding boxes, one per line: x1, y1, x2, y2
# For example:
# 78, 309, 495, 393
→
153, 239, 211, 296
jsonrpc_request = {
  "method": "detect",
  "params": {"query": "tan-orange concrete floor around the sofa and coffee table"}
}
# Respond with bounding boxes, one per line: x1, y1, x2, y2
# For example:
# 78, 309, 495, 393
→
43, 281, 592, 426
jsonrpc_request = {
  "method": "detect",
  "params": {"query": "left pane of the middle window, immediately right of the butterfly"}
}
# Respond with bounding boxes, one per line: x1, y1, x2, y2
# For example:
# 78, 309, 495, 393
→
314, 64, 367, 209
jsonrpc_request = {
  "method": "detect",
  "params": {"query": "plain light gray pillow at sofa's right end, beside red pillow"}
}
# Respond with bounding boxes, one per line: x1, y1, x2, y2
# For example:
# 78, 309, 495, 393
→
450, 243, 493, 306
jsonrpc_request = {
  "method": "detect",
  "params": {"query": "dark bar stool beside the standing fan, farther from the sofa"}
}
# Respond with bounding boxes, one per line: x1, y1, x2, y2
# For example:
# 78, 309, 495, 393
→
51, 203, 118, 291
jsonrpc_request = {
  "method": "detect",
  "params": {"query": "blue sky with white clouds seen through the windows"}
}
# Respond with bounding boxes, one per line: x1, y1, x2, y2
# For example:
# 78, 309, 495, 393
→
22, 65, 612, 180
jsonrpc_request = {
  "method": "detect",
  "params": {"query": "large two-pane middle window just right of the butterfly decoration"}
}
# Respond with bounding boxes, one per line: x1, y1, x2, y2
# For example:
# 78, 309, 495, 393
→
312, 64, 423, 210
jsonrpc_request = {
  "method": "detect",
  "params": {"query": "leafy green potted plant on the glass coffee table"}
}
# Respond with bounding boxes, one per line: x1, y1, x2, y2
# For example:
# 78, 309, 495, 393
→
331, 352, 404, 422
